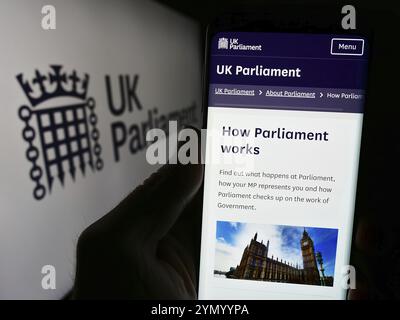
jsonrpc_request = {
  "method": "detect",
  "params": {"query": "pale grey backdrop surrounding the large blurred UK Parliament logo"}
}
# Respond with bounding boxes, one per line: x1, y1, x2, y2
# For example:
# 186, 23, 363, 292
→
0, 0, 201, 299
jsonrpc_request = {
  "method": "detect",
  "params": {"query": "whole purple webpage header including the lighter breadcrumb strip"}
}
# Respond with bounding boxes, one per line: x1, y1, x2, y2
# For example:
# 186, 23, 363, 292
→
208, 32, 369, 113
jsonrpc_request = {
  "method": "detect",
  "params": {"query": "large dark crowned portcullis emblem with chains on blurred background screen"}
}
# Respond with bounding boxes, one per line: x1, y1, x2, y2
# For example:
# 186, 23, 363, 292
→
17, 65, 103, 200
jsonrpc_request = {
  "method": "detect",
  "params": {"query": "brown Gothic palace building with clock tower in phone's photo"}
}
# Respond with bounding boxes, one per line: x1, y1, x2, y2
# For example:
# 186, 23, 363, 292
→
225, 229, 333, 286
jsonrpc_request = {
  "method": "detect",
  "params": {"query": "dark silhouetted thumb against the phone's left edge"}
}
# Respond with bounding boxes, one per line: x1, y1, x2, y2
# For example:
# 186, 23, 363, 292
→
104, 164, 203, 244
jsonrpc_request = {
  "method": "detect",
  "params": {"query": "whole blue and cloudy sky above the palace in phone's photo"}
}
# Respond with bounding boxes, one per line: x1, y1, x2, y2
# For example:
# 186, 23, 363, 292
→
215, 221, 337, 276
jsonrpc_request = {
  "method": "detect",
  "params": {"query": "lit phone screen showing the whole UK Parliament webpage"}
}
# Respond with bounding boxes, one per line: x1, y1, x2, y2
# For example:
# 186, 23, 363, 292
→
199, 32, 368, 299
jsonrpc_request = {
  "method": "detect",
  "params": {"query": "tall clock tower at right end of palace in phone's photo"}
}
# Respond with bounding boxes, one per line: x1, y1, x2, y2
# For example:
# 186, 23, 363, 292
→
300, 228, 320, 285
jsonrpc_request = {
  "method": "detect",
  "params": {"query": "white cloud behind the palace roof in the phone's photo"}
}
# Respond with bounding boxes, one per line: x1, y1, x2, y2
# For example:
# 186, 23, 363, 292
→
215, 224, 303, 271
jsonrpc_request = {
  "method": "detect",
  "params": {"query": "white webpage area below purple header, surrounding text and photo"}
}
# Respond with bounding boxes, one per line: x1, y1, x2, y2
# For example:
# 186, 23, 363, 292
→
199, 107, 362, 299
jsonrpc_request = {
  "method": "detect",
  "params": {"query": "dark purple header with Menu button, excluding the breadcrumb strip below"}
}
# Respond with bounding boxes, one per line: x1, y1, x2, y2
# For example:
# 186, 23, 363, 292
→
209, 32, 368, 90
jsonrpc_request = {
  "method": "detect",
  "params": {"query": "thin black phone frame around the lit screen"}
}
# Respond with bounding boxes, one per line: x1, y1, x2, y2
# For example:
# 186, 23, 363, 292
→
197, 5, 373, 300
